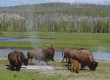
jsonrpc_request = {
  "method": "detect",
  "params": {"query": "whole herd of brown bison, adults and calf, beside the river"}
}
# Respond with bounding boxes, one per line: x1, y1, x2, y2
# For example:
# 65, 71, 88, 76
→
8, 45, 98, 73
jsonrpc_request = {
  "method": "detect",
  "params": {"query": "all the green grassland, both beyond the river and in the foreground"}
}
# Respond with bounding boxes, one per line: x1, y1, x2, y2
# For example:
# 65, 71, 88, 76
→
0, 32, 110, 80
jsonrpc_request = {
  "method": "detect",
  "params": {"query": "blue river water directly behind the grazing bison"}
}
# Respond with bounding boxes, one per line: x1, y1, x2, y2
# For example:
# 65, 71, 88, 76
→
0, 49, 110, 61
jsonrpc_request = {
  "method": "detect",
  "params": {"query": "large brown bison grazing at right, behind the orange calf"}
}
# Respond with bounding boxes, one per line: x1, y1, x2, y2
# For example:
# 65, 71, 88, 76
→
68, 49, 98, 71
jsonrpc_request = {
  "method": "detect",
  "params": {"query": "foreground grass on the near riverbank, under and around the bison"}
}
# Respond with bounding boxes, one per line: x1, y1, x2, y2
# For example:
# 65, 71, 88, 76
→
0, 60, 110, 80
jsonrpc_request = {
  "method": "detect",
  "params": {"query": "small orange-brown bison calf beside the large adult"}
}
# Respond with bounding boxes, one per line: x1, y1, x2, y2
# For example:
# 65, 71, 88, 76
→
68, 58, 80, 73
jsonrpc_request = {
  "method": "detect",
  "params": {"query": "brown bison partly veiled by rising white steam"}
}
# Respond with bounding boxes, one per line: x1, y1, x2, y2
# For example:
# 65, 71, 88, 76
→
27, 45, 55, 64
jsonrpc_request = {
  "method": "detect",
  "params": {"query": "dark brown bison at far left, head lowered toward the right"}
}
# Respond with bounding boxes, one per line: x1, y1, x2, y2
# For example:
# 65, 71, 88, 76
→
8, 51, 28, 71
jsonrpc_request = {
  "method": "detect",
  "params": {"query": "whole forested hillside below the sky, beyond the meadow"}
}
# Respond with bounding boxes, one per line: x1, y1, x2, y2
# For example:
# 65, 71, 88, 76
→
0, 3, 110, 33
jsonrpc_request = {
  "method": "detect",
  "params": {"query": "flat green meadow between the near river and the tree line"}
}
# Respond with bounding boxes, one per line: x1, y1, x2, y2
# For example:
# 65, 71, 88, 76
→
0, 32, 110, 51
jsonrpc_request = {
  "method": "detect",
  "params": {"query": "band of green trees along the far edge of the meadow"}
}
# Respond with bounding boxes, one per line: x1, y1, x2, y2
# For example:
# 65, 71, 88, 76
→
0, 15, 110, 33
